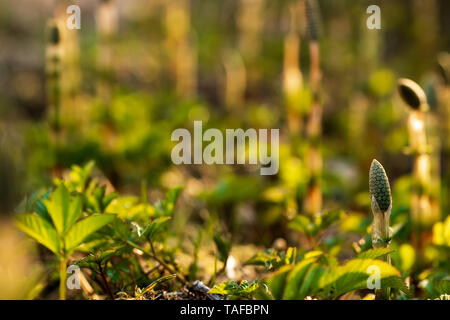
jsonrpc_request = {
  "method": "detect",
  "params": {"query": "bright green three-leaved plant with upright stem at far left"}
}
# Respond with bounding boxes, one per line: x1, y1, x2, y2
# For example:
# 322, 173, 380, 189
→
16, 184, 114, 300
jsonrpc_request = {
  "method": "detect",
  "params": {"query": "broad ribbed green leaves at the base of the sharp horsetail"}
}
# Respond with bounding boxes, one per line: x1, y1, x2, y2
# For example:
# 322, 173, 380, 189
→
258, 248, 409, 300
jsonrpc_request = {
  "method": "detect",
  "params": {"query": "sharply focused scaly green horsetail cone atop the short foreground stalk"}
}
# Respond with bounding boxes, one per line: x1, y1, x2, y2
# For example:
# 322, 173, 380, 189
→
369, 159, 392, 212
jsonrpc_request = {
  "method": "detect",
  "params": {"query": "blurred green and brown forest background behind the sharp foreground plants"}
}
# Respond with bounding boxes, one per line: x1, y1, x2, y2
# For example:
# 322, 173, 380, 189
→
0, 0, 450, 300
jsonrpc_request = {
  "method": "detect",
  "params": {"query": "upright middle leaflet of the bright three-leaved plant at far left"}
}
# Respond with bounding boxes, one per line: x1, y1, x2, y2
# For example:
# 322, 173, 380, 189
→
44, 184, 82, 236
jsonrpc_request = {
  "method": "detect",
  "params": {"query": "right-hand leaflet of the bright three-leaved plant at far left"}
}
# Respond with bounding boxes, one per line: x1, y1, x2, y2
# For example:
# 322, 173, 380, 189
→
65, 214, 115, 253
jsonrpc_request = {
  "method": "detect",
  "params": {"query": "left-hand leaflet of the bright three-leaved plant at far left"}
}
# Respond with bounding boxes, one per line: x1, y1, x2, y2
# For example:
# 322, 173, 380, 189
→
15, 213, 60, 255
